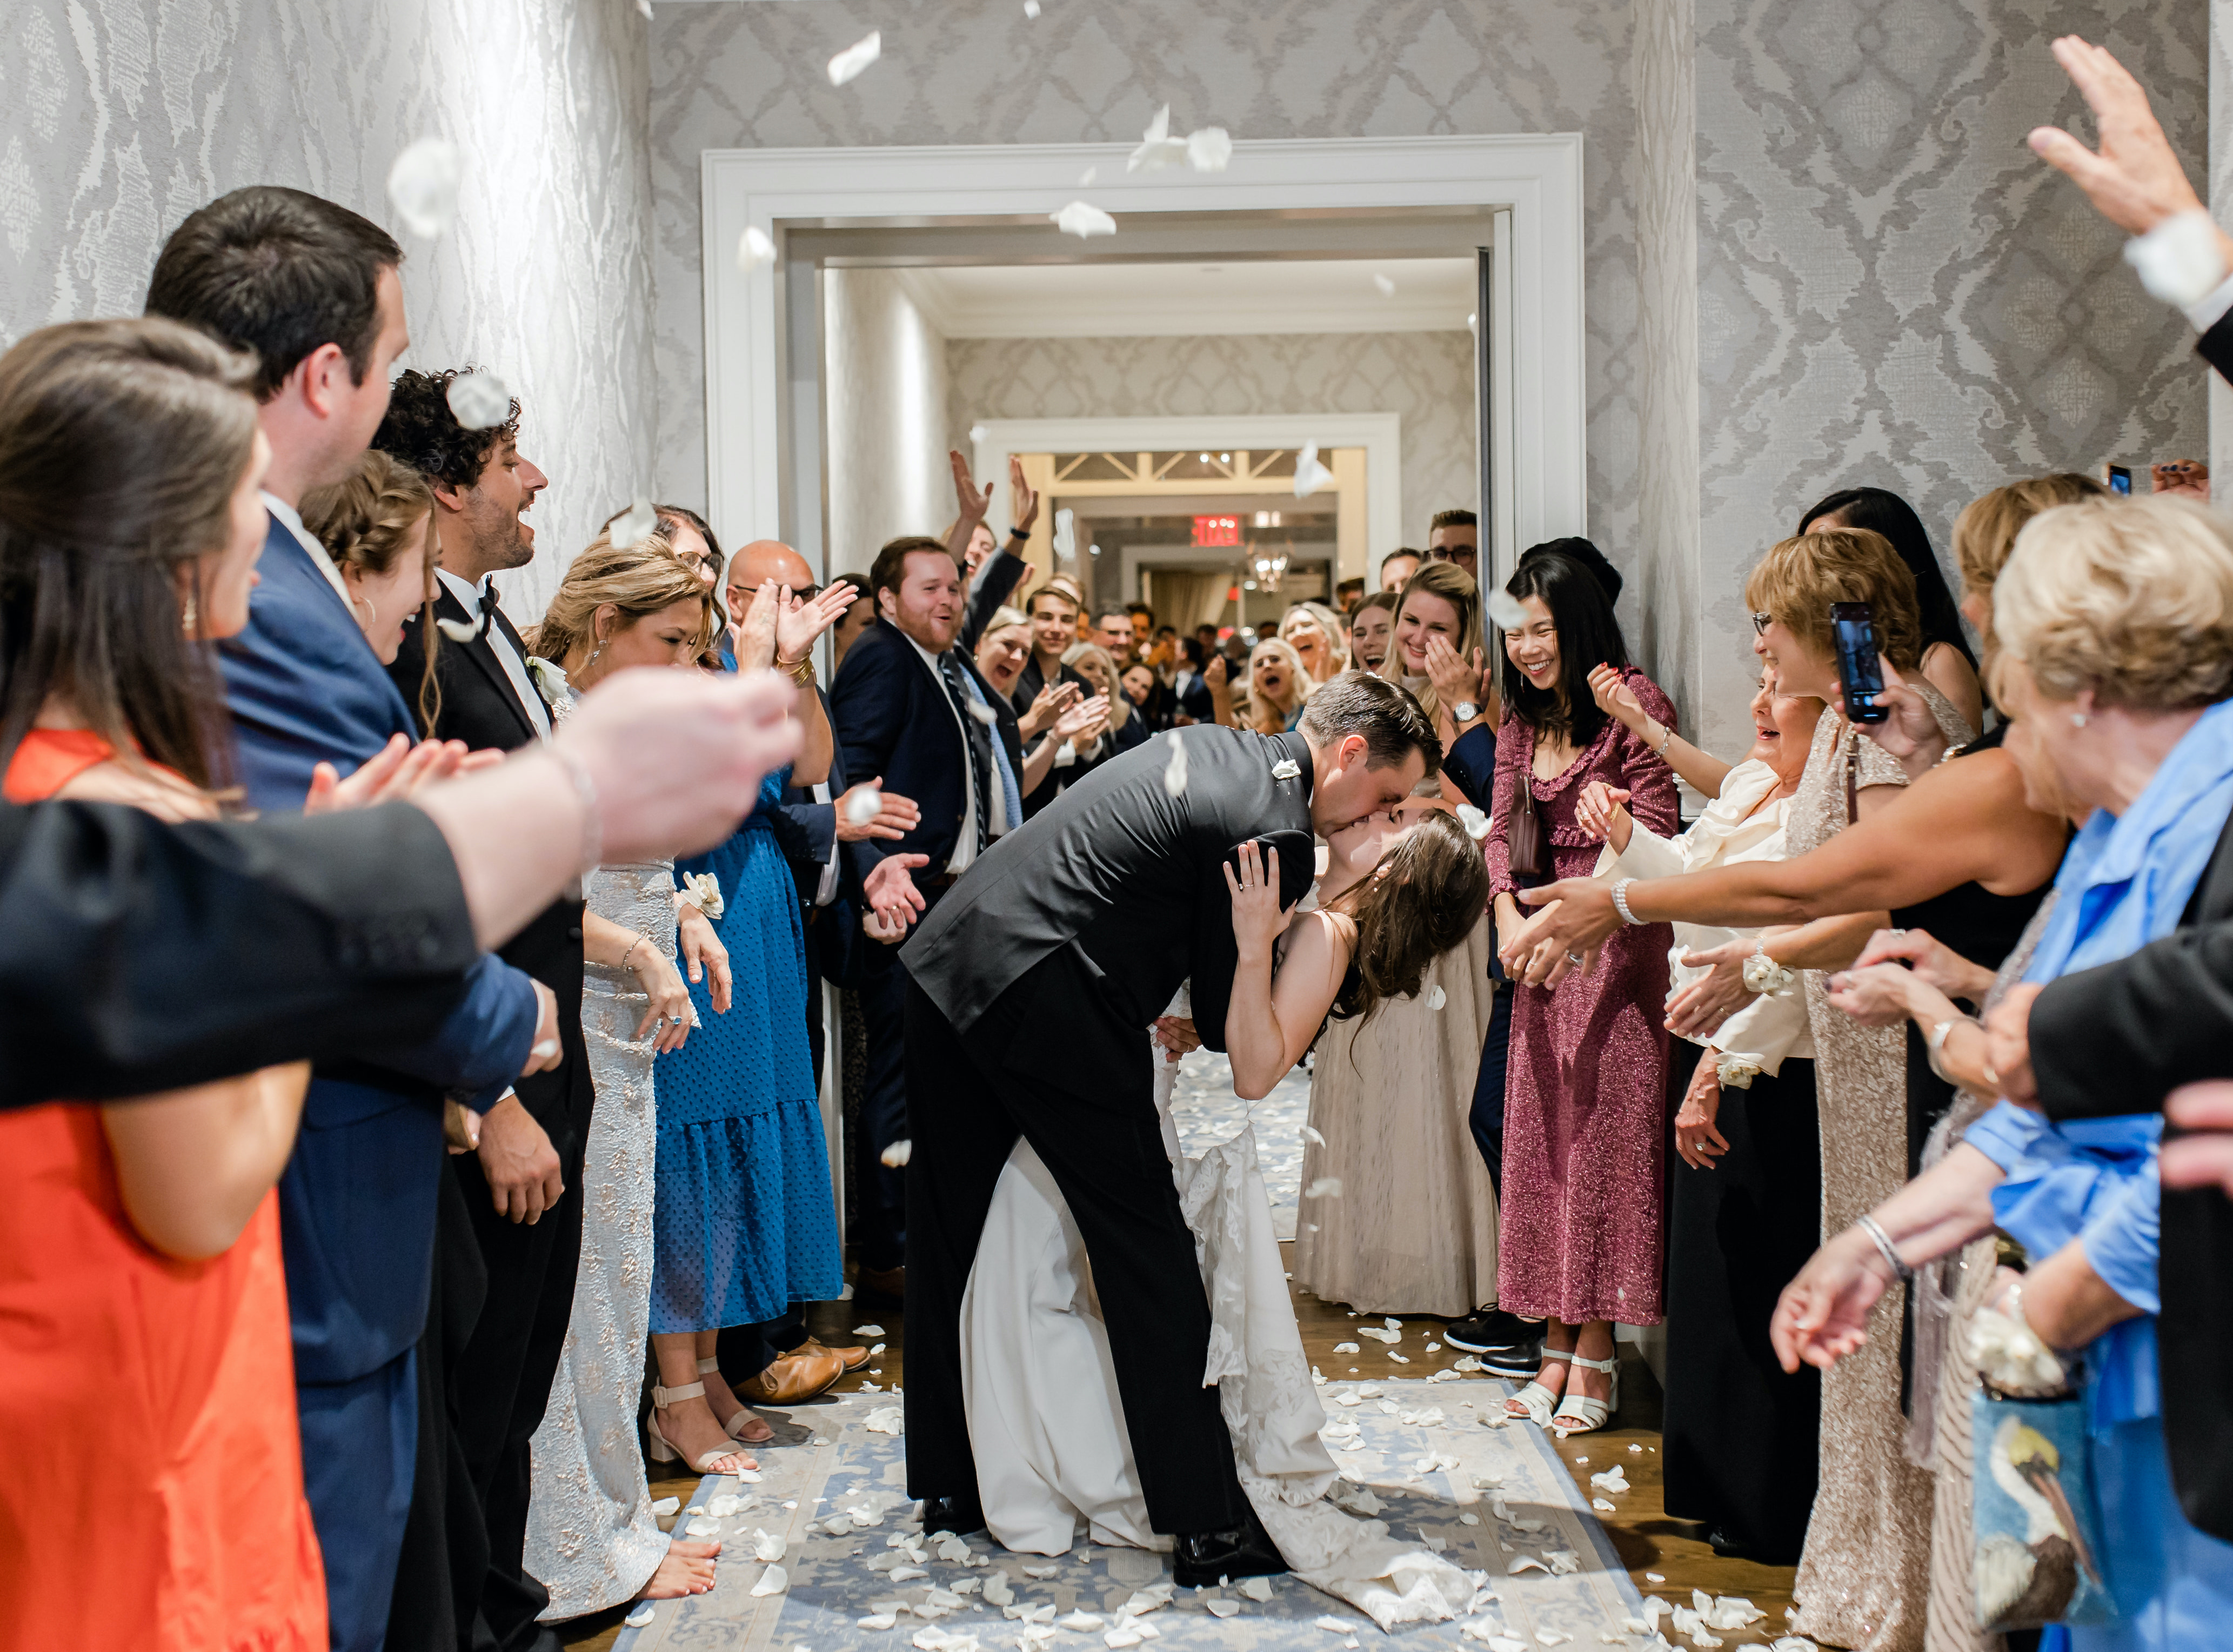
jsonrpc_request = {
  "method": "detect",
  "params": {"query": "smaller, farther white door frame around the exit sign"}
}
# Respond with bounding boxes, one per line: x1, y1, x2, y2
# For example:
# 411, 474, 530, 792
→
969, 413, 1402, 590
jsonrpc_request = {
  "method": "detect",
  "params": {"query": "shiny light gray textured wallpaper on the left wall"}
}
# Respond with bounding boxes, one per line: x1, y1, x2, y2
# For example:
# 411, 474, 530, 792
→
0, 0, 652, 612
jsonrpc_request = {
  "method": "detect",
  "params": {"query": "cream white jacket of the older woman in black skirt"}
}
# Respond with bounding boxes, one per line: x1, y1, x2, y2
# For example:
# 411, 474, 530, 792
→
1596, 757, 1813, 1089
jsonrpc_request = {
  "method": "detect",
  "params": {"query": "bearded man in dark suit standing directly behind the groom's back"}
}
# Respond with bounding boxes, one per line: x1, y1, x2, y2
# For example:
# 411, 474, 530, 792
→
831, 538, 1022, 1299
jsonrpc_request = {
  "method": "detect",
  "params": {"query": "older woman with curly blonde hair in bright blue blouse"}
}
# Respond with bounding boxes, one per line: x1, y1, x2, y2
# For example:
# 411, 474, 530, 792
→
1773, 498, 2233, 1652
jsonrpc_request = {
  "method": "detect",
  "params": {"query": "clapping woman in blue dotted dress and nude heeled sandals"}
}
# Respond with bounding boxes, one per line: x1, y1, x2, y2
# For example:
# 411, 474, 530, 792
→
645, 585, 853, 1474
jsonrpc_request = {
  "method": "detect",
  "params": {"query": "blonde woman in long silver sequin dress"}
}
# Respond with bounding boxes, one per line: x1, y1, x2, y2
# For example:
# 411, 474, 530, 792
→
527, 533, 732, 1621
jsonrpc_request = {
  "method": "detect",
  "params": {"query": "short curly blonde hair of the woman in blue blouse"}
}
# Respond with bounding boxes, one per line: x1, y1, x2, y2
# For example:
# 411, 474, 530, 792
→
1992, 496, 2233, 712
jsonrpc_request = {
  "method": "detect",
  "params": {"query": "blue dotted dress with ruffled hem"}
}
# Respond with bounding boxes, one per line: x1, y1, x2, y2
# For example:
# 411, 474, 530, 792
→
652, 770, 844, 1333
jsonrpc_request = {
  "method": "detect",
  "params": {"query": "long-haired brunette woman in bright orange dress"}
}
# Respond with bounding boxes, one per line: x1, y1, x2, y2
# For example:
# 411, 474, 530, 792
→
0, 322, 326, 1652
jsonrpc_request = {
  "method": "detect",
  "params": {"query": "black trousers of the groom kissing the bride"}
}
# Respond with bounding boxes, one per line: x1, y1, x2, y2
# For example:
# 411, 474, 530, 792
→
904, 944, 1248, 1534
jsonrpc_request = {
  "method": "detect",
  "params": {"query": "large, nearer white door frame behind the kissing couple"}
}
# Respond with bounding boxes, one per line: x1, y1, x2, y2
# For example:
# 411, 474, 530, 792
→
699, 132, 1588, 560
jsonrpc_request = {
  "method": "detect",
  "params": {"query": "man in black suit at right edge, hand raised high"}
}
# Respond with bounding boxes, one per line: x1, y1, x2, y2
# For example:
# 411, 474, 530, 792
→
1994, 36, 2233, 1540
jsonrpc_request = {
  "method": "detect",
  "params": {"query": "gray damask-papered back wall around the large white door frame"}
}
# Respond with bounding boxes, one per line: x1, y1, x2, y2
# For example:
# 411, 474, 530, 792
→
652, 0, 1637, 563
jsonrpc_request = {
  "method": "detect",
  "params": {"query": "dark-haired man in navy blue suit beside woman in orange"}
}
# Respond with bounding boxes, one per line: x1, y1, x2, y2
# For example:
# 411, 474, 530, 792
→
148, 188, 556, 1652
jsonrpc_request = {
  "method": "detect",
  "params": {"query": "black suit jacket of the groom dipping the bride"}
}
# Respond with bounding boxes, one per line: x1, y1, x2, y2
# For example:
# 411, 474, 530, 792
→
900, 723, 1315, 1058
